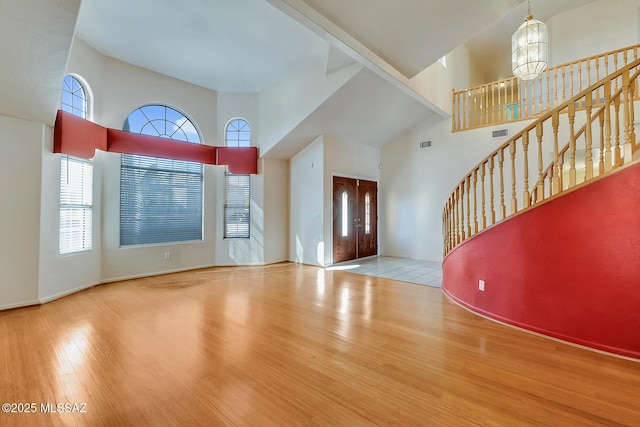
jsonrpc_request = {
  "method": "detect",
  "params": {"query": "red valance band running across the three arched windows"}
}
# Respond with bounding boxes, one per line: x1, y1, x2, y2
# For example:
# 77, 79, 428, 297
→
53, 110, 258, 174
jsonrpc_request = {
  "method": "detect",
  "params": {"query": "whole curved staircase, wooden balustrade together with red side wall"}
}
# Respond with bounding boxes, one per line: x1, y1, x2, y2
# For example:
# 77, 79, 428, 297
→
443, 59, 640, 359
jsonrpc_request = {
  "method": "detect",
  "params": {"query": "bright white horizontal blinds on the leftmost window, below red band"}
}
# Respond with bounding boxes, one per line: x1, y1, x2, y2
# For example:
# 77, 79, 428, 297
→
59, 156, 93, 254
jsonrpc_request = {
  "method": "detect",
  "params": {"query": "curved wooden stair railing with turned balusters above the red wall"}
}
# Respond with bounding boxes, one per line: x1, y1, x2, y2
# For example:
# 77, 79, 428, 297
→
442, 59, 640, 255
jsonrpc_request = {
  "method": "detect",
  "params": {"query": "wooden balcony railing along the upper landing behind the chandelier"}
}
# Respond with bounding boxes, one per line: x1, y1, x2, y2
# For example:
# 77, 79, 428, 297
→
451, 45, 640, 132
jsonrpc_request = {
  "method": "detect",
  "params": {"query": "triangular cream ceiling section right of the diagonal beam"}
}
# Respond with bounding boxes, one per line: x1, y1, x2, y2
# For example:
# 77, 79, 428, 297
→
292, 0, 522, 78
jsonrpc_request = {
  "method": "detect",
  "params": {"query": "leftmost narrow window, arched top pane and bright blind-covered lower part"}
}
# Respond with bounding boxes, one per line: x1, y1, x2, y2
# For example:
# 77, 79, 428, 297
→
58, 75, 93, 255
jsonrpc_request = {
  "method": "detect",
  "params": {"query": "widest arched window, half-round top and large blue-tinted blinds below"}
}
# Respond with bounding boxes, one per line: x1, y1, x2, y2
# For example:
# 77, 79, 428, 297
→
120, 105, 204, 246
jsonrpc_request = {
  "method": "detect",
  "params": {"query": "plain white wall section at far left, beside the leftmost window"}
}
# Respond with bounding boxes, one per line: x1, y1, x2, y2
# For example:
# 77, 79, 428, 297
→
0, 116, 46, 309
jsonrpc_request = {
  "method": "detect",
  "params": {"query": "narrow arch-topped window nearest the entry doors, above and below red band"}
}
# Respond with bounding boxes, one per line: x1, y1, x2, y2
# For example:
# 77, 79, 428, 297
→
224, 119, 251, 239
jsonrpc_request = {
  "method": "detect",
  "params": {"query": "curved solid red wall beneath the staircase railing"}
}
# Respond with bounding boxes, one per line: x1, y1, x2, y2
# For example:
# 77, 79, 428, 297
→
442, 164, 640, 359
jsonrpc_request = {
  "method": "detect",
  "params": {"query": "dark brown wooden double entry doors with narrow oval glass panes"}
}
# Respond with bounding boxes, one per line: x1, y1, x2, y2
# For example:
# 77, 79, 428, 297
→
333, 176, 378, 263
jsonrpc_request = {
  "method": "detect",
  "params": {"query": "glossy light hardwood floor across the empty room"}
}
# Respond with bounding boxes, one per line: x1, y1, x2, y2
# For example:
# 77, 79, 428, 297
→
0, 263, 640, 426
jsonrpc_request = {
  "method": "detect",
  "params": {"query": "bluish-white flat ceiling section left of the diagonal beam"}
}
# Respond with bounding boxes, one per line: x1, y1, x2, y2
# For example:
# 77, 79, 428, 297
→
76, 0, 327, 92
